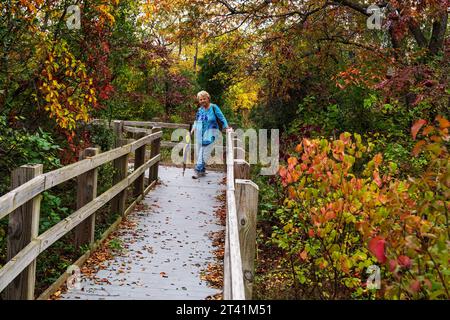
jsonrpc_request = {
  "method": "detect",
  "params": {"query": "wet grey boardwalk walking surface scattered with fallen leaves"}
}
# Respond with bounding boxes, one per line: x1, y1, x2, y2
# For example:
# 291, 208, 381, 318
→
61, 166, 225, 300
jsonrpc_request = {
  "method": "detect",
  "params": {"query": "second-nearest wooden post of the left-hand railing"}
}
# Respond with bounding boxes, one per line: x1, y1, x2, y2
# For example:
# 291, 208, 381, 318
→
74, 148, 100, 250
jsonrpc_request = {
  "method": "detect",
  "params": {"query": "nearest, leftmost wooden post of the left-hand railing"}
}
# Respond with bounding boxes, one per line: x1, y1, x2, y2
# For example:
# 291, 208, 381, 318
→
5, 164, 43, 300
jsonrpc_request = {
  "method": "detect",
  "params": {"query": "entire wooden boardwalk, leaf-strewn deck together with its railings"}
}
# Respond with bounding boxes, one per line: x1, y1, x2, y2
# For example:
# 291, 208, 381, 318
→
0, 120, 258, 300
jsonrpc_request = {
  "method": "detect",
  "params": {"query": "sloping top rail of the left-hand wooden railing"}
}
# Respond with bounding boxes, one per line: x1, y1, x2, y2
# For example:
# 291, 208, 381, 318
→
0, 132, 162, 219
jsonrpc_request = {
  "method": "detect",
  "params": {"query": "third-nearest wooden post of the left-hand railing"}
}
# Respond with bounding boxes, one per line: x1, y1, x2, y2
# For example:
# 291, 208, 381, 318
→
111, 139, 130, 215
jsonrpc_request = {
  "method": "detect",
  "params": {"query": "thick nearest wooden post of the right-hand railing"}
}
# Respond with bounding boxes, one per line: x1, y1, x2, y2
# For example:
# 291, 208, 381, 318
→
235, 179, 259, 300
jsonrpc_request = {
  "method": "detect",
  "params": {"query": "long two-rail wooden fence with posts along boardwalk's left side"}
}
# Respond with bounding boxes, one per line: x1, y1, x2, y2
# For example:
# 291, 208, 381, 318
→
0, 128, 162, 300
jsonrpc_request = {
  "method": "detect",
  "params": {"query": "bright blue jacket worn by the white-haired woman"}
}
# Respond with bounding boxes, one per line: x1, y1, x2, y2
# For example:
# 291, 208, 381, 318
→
194, 103, 228, 145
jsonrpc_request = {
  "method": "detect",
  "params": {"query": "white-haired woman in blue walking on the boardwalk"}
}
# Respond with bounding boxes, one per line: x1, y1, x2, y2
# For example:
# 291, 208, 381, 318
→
191, 91, 232, 179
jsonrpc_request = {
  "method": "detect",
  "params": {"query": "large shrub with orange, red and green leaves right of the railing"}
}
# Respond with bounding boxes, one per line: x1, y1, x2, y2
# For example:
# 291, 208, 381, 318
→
272, 117, 450, 299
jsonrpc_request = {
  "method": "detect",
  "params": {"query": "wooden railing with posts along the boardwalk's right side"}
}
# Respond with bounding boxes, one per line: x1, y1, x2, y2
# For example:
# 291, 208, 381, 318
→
223, 132, 259, 300
